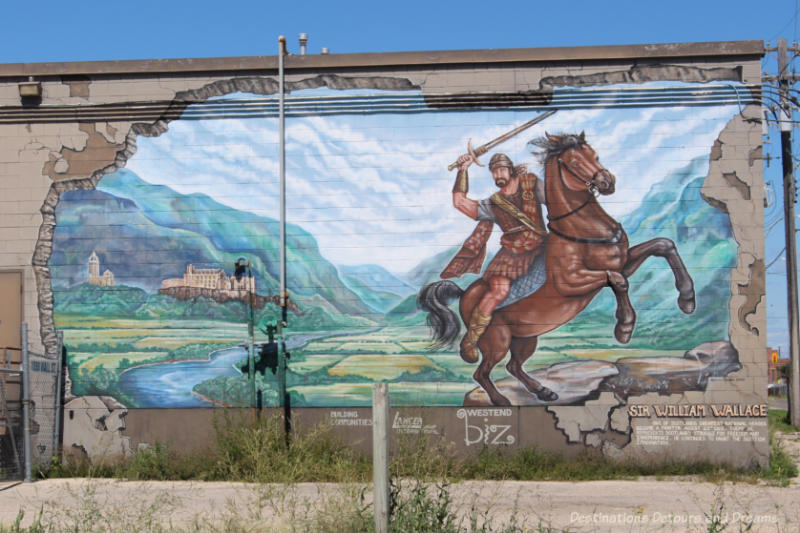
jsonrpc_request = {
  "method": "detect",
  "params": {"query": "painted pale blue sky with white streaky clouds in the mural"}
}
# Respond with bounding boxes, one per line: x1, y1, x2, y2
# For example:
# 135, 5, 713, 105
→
126, 84, 738, 273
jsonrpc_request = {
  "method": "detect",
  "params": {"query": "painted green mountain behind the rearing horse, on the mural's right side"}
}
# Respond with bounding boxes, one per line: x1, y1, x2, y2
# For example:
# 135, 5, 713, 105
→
404, 156, 737, 348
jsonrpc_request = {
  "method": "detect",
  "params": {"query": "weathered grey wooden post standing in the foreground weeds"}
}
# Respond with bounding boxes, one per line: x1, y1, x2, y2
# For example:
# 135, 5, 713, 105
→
372, 383, 389, 533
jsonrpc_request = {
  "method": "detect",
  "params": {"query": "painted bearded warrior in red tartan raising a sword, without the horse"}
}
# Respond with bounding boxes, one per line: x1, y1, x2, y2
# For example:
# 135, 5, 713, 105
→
441, 153, 547, 363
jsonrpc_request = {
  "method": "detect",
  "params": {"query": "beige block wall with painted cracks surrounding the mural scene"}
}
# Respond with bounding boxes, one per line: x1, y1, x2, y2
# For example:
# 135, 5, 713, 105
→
0, 43, 768, 464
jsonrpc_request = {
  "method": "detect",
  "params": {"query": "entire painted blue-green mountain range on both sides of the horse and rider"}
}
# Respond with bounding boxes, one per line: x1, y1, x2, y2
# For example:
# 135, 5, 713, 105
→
50, 156, 737, 350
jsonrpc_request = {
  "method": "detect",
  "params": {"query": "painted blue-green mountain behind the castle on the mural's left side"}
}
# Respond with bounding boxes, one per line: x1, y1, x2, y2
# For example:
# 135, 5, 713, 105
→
49, 169, 371, 316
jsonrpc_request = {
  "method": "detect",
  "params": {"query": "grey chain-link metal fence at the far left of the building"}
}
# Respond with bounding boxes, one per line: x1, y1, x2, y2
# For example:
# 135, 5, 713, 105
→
0, 324, 63, 481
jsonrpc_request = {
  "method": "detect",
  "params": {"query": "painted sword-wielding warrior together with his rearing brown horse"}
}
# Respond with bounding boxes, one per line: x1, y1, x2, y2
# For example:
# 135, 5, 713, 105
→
417, 131, 696, 405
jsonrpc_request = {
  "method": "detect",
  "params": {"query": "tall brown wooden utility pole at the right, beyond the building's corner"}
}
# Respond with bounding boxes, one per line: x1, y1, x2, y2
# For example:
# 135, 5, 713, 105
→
778, 39, 800, 426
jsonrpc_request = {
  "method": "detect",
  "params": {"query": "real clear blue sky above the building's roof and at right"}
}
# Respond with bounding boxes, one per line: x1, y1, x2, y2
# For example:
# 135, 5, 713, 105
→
0, 0, 798, 354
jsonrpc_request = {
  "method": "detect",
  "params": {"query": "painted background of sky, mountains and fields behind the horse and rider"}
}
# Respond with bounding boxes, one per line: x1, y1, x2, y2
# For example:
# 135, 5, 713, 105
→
50, 84, 738, 407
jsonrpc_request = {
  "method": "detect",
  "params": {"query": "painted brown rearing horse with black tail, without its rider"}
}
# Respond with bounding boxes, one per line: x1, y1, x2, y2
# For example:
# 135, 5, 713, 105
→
417, 132, 695, 405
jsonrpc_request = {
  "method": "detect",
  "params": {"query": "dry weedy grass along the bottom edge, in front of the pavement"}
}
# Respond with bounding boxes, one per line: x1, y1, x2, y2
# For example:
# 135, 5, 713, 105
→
0, 482, 550, 533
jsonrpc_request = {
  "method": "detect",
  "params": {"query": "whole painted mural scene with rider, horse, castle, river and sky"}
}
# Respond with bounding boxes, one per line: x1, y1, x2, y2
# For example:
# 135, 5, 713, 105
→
49, 84, 741, 407
